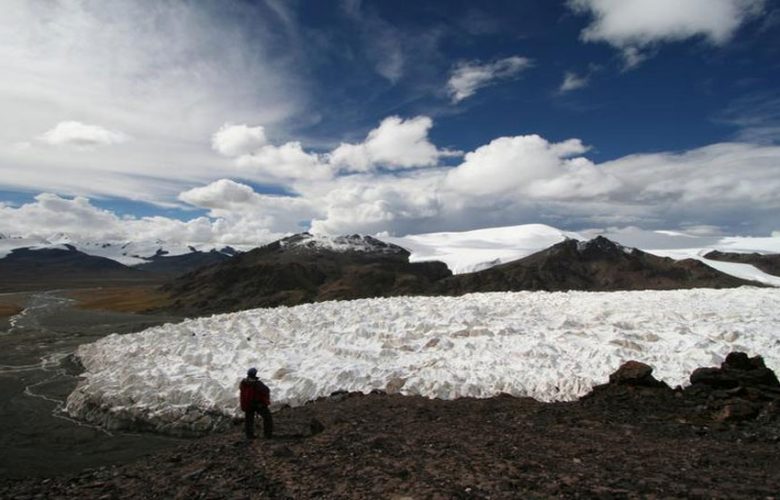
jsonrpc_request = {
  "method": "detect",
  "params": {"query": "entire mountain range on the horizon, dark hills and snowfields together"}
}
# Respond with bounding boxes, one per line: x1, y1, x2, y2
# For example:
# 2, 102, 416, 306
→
0, 224, 780, 300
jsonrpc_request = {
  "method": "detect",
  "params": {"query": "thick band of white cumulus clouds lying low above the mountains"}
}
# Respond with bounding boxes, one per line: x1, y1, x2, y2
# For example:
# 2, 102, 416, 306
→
0, 117, 780, 245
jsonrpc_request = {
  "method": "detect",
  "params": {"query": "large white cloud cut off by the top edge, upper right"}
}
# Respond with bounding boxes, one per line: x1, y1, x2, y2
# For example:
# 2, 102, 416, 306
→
569, 0, 766, 67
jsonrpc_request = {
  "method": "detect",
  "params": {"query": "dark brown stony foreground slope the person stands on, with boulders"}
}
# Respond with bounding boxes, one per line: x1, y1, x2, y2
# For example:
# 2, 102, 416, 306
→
0, 353, 780, 499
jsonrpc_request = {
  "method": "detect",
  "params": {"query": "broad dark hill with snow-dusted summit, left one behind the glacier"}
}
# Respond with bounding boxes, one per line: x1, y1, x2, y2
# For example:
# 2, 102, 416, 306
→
163, 233, 451, 314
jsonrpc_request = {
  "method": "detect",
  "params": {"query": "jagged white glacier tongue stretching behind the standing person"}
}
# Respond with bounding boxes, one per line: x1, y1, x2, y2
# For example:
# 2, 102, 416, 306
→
66, 287, 780, 434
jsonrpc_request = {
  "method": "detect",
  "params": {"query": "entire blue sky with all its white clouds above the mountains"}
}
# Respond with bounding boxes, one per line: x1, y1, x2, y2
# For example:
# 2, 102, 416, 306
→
0, 0, 780, 245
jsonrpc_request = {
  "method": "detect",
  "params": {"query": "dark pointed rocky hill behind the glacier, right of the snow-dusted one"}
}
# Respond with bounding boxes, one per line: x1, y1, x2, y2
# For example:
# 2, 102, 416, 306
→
436, 237, 755, 294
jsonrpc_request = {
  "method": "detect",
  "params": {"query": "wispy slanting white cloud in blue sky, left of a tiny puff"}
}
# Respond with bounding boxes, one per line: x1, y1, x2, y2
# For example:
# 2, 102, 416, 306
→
447, 56, 533, 103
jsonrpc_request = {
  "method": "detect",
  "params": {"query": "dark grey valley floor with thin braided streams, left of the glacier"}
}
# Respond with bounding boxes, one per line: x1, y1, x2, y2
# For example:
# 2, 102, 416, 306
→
0, 291, 180, 479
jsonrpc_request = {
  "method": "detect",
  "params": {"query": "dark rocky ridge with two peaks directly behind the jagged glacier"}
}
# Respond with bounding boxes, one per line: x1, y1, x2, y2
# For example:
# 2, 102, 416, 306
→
162, 233, 757, 316
